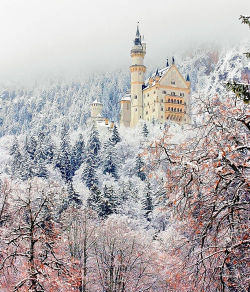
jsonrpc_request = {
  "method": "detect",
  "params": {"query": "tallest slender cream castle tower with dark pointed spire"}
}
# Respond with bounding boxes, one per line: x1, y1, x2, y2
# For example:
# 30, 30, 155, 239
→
130, 25, 146, 127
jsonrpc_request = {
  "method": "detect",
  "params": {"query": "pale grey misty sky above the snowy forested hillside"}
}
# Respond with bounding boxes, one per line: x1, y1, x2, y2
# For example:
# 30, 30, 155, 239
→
0, 0, 250, 79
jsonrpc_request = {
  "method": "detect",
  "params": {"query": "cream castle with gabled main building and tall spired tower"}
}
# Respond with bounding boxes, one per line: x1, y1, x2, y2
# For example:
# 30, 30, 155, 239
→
120, 26, 190, 127
